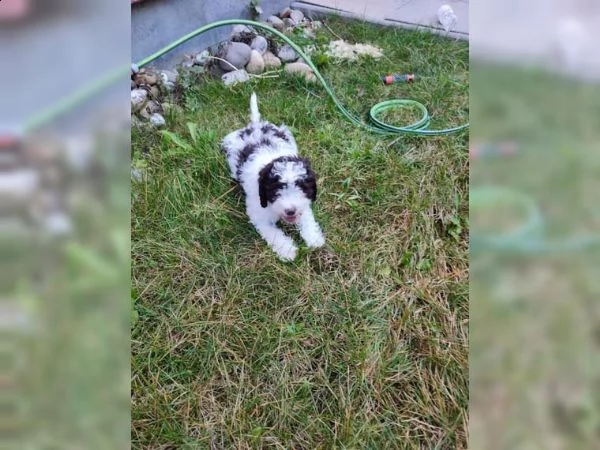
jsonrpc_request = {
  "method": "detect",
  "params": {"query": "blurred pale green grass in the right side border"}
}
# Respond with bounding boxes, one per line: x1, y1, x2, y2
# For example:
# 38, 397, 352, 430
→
470, 64, 600, 449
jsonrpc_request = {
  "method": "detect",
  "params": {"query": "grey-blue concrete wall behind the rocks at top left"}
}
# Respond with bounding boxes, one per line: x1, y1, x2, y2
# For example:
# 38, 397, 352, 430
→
131, 0, 291, 68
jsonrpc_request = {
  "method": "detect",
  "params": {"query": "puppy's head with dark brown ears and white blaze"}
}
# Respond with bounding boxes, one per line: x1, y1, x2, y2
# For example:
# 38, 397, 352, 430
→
258, 156, 317, 223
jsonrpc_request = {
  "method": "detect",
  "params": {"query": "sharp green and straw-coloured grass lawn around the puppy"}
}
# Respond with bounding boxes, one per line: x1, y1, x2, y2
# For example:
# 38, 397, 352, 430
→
132, 20, 469, 449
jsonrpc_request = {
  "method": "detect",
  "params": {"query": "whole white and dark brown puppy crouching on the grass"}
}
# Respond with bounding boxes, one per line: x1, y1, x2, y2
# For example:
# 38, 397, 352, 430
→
221, 93, 325, 261
